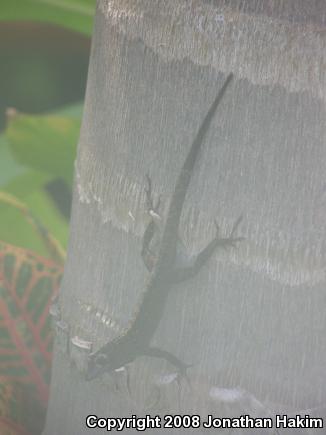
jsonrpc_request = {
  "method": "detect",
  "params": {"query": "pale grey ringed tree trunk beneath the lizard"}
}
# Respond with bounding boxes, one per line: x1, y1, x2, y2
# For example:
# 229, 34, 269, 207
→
44, 0, 326, 435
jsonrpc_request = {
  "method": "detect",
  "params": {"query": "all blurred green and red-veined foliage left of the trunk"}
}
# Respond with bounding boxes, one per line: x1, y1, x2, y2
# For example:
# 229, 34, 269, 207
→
0, 0, 95, 435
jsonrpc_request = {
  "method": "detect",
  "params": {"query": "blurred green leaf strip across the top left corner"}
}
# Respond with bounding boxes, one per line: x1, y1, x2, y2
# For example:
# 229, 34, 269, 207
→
0, 0, 96, 35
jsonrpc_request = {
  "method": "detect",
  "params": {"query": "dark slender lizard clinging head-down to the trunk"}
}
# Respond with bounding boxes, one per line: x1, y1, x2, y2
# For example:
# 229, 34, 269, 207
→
85, 73, 242, 380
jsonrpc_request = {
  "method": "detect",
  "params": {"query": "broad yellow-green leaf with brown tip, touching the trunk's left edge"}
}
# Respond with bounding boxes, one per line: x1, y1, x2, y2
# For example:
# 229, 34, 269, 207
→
5, 113, 80, 185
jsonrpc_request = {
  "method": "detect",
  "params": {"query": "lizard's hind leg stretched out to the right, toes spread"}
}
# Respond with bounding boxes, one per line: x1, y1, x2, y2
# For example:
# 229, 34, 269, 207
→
172, 216, 244, 283
